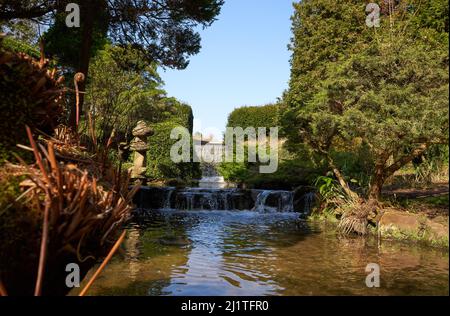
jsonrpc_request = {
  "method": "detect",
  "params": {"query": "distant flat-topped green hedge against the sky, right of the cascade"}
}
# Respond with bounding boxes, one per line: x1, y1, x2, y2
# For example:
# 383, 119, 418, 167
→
227, 104, 279, 129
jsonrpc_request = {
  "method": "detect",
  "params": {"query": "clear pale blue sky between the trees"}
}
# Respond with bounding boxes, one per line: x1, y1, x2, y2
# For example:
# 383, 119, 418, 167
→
161, 0, 293, 138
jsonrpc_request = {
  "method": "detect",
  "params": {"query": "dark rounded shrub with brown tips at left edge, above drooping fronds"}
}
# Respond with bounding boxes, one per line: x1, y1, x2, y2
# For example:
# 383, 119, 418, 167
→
0, 38, 64, 162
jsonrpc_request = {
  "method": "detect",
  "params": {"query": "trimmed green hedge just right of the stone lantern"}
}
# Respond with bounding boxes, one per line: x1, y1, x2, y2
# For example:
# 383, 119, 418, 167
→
147, 105, 201, 181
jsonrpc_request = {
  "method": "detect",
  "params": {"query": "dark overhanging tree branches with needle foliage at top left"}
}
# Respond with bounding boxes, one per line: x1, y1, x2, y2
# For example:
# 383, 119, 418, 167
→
0, 0, 223, 125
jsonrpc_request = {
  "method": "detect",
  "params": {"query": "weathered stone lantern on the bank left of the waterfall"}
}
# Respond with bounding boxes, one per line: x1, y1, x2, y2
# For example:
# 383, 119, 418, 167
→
130, 121, 154, 179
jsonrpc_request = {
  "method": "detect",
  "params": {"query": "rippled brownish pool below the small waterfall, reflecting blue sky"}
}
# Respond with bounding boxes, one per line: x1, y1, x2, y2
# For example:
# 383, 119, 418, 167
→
76, 210, 449, 296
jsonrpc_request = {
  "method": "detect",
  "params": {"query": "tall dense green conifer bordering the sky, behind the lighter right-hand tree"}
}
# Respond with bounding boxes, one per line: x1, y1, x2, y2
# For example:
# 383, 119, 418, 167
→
287, 0, 370, 111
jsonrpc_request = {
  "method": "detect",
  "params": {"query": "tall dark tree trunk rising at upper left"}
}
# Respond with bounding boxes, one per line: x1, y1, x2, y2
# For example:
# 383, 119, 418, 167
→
69, 0, 95, 129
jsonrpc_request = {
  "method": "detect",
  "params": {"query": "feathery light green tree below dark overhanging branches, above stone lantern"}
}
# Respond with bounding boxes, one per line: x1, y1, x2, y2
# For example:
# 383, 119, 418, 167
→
84, 45, 177, 141
